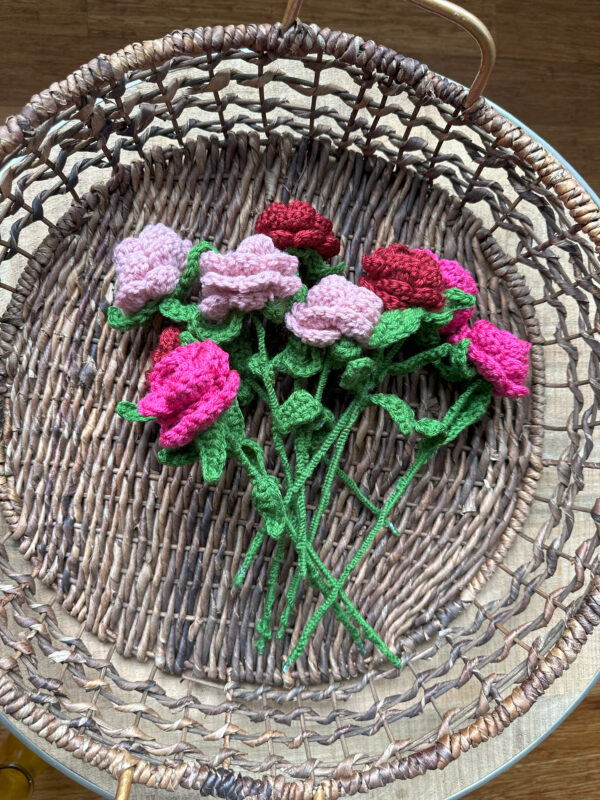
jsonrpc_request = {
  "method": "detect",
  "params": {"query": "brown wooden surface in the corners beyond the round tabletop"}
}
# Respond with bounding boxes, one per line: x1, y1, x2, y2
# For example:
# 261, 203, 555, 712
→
0, 0, 600, 800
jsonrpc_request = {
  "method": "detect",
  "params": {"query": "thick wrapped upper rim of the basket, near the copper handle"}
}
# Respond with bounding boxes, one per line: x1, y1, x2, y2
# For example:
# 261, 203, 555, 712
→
0, 22, 600, 252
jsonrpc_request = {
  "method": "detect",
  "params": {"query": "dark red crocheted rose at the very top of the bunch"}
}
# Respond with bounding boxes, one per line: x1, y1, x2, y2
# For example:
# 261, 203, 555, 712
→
256, 200, 340, 258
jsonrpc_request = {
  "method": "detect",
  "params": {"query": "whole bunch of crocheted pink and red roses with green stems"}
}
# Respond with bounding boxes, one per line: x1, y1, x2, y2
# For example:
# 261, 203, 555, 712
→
108, 201, 530, 671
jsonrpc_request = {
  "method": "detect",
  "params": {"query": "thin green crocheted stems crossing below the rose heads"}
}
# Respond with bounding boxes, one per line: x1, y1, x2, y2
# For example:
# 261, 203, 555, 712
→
234, 319, 488, 672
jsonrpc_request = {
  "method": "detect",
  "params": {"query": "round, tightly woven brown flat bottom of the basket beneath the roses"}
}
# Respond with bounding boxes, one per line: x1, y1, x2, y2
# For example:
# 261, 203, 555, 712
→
0, 134, 541, 685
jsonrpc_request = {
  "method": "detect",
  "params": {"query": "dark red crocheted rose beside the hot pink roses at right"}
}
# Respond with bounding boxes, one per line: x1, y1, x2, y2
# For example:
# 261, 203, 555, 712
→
358, 244, 446, 311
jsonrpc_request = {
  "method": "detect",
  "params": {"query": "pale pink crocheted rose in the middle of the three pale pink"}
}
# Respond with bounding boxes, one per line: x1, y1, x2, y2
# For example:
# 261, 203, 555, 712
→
200, 234, 302, 322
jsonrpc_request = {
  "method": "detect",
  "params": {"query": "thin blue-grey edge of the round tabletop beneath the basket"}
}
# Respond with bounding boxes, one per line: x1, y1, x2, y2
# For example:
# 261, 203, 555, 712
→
0, 99, 600, 800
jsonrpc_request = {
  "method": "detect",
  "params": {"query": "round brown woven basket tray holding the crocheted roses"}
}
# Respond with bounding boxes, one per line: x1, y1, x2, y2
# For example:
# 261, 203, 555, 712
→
0, 1, 600, 800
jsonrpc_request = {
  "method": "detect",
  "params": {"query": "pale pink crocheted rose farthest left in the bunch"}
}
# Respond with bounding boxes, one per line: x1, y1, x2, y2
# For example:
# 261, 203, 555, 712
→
113, 223, 192, 314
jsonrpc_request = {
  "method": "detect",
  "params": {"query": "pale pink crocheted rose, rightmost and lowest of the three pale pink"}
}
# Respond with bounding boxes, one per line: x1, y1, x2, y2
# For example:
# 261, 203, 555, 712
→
285, 275, 383, 347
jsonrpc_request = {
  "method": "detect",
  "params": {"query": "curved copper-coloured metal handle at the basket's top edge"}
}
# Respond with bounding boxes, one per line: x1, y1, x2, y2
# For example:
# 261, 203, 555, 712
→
282, 0, 496, 108
